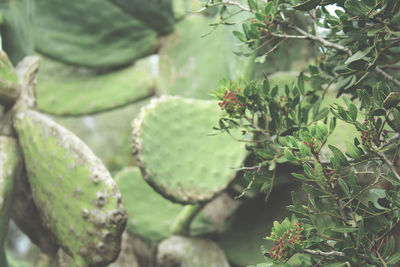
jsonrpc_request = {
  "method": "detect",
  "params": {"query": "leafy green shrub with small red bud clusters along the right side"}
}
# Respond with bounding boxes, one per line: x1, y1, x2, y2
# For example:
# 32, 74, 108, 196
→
208, 0, 400, 266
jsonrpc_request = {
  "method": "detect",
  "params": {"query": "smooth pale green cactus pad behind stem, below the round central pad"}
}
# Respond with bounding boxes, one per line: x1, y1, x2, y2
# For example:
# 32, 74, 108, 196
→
115, 167, 233, 241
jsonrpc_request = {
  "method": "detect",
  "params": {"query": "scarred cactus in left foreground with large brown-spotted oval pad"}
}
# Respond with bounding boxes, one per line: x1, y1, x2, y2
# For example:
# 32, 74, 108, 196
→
0, 54, 126, 266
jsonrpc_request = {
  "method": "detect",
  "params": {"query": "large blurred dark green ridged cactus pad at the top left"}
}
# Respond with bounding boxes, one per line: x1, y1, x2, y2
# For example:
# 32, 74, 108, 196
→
35, 0, 158, 69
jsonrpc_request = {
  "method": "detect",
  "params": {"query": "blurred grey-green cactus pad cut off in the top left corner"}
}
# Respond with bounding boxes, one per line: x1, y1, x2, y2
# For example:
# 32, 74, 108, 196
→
0, 0, 34, 65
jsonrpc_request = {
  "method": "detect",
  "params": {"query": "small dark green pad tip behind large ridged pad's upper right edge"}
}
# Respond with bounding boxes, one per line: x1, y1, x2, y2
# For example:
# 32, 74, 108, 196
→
110, 0, 175, 34
